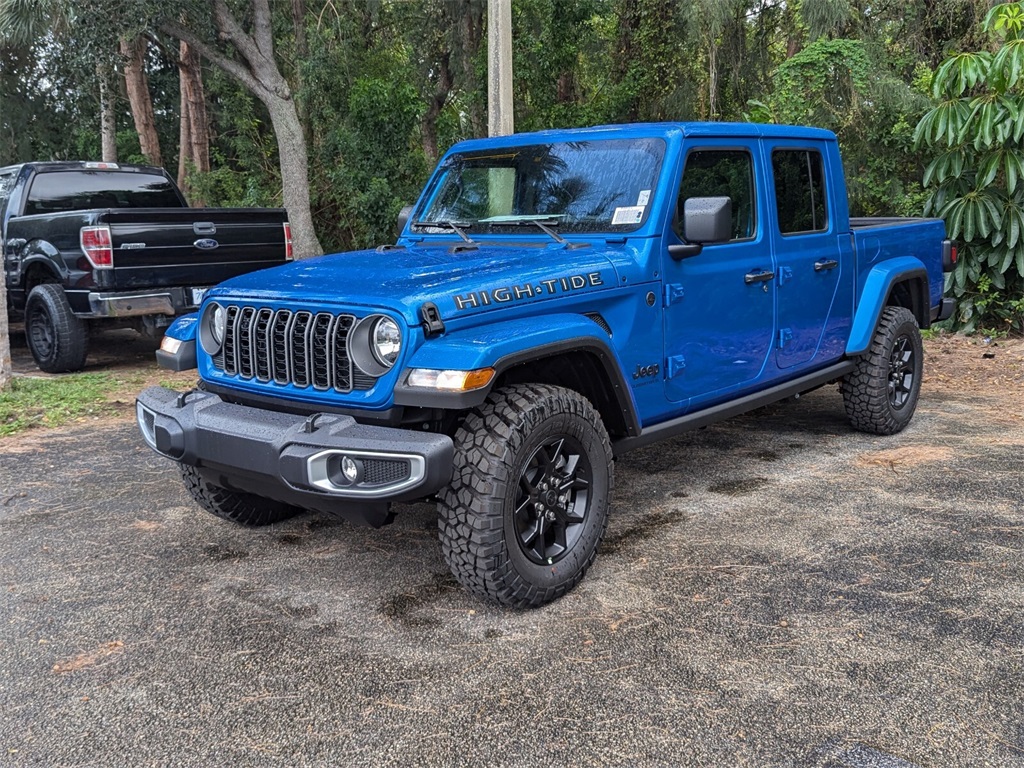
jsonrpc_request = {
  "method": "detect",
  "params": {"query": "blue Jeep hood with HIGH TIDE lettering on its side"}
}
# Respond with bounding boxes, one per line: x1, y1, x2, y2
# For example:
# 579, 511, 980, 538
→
210, 243, 618, 325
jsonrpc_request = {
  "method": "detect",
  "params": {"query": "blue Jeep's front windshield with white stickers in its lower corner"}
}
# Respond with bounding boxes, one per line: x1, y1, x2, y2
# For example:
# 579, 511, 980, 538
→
413, 138, 665, 232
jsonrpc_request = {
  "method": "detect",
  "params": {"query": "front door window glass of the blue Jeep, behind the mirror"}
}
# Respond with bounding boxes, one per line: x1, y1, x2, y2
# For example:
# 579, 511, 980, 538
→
673, 150, 757, 241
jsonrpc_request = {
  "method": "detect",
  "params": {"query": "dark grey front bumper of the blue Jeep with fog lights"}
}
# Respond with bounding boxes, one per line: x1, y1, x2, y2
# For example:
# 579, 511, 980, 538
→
136, 387, 454, 525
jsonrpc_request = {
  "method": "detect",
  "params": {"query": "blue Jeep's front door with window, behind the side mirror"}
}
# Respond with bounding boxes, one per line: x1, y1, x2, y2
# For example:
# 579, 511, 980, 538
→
664, 141, 775, 410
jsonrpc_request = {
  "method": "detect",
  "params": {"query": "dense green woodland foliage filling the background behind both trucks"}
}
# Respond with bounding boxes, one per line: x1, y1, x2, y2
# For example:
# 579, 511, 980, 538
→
0, 0, 999, 262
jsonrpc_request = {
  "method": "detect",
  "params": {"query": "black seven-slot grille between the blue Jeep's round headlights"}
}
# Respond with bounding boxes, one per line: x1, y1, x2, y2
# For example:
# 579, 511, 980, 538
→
213, 305, 376, 392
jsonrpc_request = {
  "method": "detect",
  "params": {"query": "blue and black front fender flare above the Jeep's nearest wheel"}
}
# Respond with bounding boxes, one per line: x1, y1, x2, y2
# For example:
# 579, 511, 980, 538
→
394, 313, 640, 435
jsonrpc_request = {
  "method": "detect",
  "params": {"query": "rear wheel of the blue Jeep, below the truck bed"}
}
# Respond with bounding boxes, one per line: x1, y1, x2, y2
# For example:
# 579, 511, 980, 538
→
840, 306, 925, 434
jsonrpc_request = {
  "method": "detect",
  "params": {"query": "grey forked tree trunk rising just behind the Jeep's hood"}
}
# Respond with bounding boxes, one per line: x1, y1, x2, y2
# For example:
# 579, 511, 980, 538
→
161, 0, 324, 258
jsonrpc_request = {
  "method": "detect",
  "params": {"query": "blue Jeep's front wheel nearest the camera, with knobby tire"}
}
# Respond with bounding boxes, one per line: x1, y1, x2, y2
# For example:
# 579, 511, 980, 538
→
438, 384, 613, 607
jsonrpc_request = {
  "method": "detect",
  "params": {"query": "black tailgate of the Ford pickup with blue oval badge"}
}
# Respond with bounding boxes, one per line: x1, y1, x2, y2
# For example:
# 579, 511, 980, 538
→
102, 208, 288, 291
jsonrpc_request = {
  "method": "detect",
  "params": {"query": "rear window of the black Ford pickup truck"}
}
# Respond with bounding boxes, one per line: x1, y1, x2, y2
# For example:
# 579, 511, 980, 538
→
25, 171, 182, 215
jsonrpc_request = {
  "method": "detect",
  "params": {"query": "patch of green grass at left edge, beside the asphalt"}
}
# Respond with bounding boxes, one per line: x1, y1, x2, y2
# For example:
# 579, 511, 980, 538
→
0, 374, 115, 437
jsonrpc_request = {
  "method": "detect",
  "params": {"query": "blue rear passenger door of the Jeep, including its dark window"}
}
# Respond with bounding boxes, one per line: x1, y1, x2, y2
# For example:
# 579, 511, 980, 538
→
765, 145, 853, 369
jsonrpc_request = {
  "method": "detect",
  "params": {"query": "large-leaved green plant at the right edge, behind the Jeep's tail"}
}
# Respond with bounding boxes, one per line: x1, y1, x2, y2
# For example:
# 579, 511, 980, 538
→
914, 3, 1024, 331
